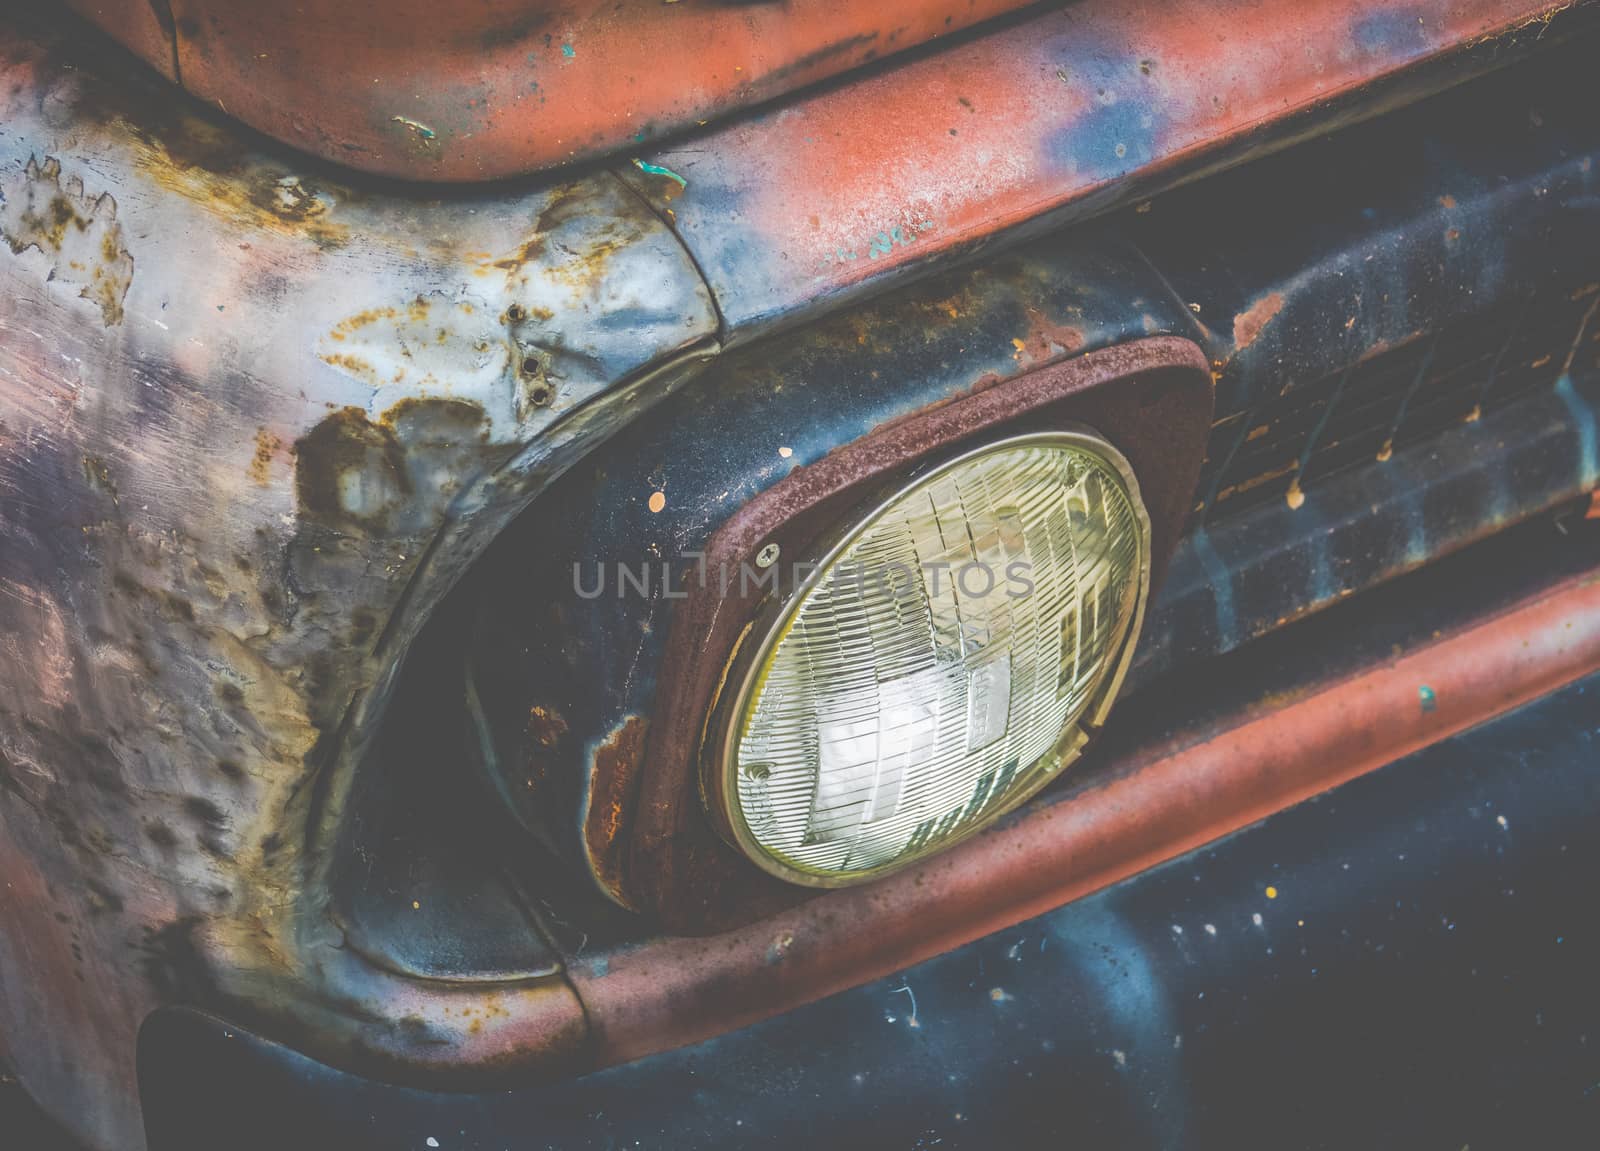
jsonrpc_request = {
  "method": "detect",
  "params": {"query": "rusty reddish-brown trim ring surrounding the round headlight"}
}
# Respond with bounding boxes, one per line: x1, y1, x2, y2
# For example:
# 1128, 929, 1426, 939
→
614, 336, 1213, 933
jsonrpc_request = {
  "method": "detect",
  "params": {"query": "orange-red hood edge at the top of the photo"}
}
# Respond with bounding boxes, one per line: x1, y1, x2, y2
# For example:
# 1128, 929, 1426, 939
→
70, 0, 1027, 181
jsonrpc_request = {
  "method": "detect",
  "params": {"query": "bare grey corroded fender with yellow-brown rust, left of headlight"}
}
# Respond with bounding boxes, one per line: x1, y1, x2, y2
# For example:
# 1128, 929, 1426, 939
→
0, 16, 715, 1146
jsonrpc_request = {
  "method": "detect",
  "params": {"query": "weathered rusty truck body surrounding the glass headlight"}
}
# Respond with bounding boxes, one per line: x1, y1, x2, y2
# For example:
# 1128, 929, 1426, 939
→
0, 0, 1600, 1151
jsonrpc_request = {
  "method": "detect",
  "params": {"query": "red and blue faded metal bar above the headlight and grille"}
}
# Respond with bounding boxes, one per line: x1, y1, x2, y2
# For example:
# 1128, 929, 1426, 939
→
619, 0, 1593, 338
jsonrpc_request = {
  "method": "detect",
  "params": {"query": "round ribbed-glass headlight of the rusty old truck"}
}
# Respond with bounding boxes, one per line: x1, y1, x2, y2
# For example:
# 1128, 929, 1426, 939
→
707, 432, 1150, 887
